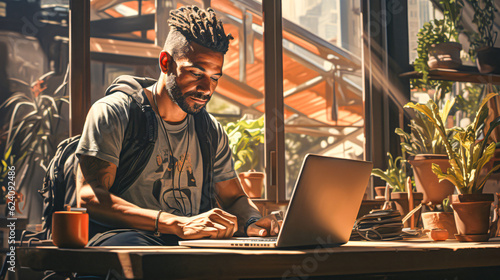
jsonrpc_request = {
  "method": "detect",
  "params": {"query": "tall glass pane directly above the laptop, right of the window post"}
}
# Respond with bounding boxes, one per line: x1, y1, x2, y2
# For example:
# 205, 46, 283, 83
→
283, 0, 365, 198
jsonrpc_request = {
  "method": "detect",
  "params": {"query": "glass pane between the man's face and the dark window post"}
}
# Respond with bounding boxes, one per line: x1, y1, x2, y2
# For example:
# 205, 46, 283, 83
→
208, 0, 265, 197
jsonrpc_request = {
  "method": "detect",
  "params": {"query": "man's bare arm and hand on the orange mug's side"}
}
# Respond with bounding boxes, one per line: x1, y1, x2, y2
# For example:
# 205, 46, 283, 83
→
76, 155, 236, 238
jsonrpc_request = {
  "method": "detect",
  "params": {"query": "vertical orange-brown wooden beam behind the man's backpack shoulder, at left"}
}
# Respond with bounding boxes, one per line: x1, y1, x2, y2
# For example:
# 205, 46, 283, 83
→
69, 0, 91, 136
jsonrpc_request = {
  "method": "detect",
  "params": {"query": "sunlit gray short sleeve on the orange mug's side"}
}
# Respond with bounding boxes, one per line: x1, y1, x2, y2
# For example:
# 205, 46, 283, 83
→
76, 93, 130, 166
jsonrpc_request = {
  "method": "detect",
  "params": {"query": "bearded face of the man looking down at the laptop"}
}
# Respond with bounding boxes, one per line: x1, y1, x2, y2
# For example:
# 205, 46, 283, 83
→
166, 43, 224, 114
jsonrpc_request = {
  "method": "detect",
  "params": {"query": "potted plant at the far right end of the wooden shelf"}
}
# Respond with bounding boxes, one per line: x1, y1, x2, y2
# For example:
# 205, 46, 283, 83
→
467, 0, 500, 74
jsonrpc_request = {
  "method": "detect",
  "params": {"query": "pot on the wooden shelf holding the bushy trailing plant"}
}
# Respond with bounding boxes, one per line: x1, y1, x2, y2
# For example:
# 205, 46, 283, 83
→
427, 42, 462, 69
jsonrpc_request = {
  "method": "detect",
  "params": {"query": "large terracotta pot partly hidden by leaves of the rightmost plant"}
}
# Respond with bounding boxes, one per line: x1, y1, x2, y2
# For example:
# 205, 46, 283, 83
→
408, 154, 455, 204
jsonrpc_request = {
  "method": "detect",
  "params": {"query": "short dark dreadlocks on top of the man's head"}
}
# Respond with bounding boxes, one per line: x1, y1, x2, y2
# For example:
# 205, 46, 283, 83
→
167, 6, 233, 54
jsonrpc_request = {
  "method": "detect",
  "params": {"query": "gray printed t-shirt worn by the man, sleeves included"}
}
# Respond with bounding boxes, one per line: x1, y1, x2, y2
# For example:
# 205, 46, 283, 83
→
76, 92, 236, 216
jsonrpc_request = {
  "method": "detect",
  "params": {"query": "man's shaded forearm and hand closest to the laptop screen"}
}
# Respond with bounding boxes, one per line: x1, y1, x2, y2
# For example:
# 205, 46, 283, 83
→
215, 178, 281, 236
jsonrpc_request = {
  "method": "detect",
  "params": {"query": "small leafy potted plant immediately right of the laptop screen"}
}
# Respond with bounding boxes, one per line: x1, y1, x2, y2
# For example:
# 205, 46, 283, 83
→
372, 153, 423, 227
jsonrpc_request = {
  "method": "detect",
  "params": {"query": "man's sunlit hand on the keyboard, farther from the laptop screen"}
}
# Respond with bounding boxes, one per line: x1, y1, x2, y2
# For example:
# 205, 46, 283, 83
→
176, 208, 238, 239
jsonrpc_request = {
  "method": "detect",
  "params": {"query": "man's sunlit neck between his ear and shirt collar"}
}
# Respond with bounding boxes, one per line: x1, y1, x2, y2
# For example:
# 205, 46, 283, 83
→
144, 84, 187, 124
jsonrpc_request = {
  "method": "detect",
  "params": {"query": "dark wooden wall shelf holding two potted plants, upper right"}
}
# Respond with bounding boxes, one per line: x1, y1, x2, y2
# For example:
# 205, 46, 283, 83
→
399, 66, 500, 85
